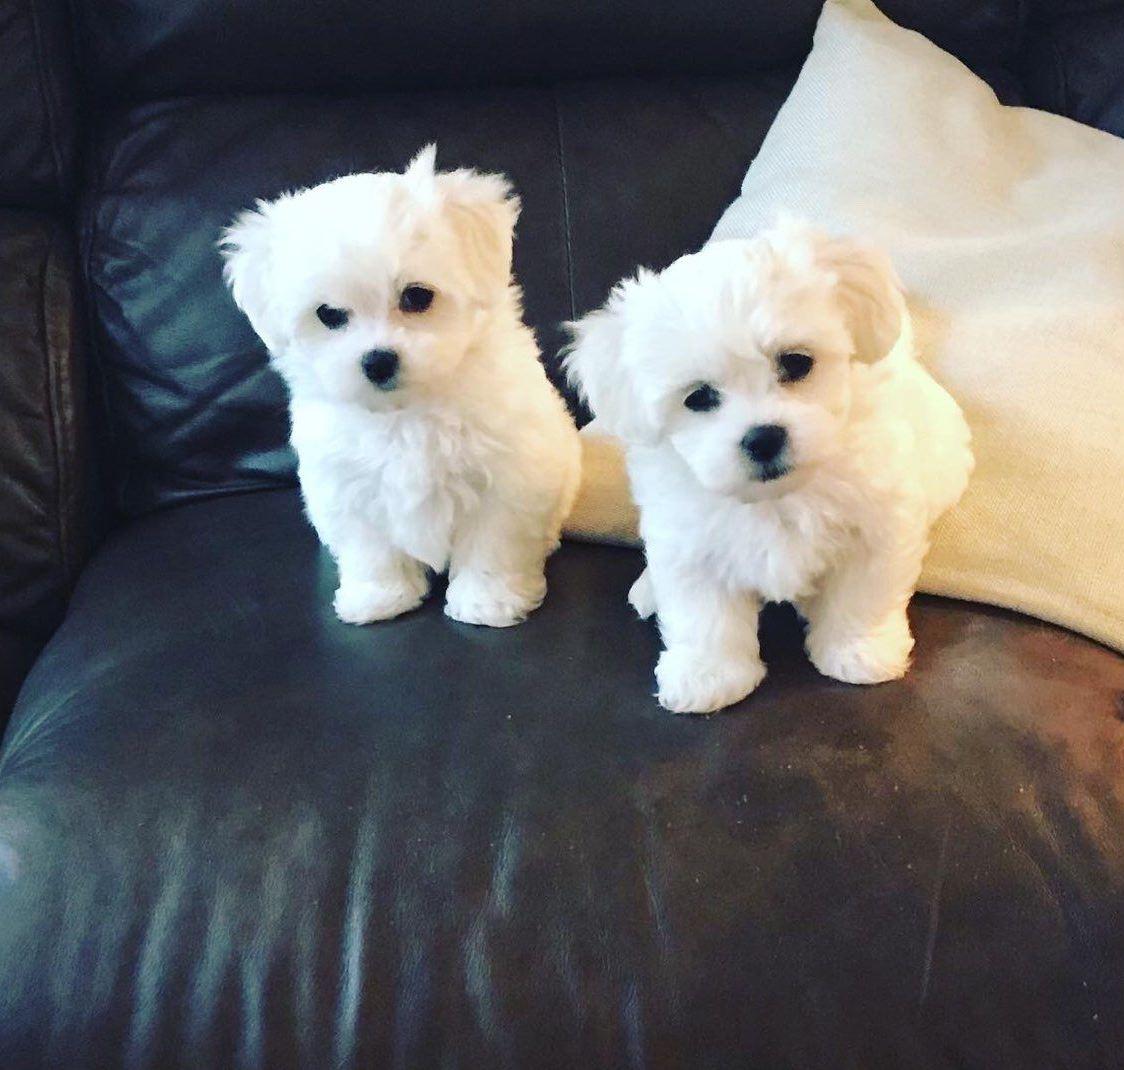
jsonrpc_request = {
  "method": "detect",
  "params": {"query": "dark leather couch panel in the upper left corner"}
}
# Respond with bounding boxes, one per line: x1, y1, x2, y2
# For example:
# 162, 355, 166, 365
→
0, 0, 76, 206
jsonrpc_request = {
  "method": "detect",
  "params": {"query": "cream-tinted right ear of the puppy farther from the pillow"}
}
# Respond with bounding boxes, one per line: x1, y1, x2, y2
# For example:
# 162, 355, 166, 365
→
415, 145, 519, 306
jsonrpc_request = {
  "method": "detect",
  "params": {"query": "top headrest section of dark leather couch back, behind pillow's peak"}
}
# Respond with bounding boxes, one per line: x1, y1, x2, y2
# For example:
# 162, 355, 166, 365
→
70, 0, 1023, 99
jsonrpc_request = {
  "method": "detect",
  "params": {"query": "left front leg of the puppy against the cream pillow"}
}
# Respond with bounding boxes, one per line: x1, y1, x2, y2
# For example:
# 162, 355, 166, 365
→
649, 559, 765, 714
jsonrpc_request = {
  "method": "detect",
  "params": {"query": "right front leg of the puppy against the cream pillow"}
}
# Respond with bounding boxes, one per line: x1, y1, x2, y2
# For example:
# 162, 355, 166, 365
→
800, 541, 925, 683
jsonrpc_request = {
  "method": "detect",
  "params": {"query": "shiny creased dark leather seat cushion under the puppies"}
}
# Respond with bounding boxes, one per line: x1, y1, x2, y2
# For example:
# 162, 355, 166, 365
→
0, 491, 1124, 1070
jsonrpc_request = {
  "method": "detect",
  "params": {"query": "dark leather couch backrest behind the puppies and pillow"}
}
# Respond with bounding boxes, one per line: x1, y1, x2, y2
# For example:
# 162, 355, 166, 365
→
54, 0, 1124, 515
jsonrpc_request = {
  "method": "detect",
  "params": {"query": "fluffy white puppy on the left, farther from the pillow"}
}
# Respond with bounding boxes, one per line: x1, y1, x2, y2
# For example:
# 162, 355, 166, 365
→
221, 145, 580, 627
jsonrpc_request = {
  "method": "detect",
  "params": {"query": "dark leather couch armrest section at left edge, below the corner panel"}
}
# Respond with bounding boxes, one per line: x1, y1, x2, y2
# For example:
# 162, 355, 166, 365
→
0, 211, 87, 637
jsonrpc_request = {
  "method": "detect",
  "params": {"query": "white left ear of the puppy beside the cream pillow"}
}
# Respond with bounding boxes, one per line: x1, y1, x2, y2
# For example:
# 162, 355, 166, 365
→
562, 270, 660, 445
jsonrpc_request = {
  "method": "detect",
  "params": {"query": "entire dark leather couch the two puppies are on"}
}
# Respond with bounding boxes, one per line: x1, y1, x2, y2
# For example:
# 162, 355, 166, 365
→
0, 0, 1124, 1070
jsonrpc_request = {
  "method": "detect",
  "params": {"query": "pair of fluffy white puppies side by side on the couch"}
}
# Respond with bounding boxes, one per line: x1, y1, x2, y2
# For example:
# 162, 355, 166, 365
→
224, 147, 971, 713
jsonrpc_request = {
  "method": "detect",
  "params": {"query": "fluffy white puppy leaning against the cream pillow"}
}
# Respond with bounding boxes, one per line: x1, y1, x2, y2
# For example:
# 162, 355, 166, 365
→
566, 219, 972, 713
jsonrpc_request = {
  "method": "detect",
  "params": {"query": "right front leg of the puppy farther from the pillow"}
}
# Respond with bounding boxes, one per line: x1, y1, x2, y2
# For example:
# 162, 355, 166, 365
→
445, 501, 547, 628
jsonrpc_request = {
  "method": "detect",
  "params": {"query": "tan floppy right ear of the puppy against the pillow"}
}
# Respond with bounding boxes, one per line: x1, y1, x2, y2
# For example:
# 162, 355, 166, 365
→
816, 235, 905, 362
